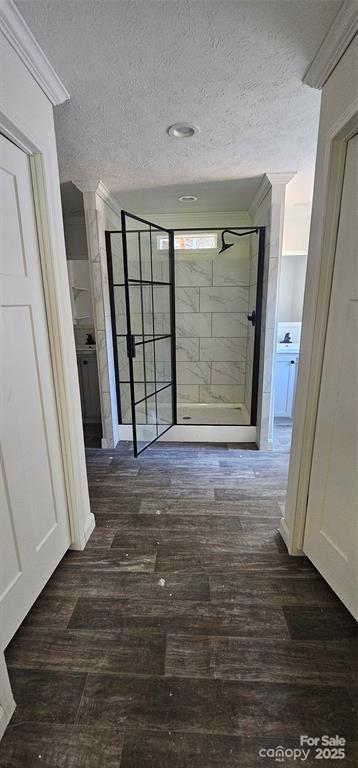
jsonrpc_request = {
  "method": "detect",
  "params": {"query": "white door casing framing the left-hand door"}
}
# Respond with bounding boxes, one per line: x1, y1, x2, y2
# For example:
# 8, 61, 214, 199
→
0, 112, 95, 550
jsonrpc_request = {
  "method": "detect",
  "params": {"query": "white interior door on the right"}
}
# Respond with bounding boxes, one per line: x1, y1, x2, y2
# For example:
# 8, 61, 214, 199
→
304, 135, 358, 618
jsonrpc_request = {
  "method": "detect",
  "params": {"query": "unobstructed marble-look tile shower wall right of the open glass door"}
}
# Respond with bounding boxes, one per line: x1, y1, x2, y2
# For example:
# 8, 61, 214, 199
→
175, 254, 250, 403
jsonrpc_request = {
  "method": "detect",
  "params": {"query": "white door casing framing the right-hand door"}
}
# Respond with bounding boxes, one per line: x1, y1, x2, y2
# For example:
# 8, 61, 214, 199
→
280, 105, 358, 555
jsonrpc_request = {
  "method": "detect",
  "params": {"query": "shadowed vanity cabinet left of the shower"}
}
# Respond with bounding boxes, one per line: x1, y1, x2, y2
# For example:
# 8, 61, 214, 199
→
77, 348, 101, 424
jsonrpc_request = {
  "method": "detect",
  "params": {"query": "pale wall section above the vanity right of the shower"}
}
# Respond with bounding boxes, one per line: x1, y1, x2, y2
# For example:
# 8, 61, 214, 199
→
278, 254, 307, 323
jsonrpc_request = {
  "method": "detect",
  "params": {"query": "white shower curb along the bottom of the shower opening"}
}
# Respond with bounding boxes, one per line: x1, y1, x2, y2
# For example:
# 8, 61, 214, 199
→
118, 424, 256, 443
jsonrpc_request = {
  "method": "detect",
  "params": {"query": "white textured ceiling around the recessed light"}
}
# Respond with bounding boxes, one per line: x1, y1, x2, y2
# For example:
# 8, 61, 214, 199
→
17, 0, 341, 211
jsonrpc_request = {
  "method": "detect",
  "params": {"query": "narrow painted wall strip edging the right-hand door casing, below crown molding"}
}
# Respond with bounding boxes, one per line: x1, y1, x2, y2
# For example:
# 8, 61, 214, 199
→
280, 37, 358, 554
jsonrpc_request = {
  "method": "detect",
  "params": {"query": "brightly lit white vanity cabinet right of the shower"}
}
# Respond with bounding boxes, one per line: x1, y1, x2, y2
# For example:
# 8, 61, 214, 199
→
275, 347, 299, 419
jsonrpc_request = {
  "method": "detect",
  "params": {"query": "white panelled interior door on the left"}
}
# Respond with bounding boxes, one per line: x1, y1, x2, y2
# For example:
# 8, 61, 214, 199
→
0, 136, 70, 650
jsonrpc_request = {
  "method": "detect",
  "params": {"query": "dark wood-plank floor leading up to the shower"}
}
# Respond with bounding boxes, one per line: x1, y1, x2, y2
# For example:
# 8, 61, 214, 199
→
0, 436, 356, 768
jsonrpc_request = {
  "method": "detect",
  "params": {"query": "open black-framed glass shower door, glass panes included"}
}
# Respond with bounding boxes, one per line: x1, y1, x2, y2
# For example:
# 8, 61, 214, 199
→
106, 211, 177, 456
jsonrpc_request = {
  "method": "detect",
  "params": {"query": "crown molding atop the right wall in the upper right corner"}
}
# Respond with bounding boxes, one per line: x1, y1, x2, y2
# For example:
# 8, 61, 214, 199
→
303, 0, 358, 88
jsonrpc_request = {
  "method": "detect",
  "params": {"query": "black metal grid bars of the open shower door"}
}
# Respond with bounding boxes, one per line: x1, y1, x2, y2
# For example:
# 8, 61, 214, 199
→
106, 211, 176, 456
